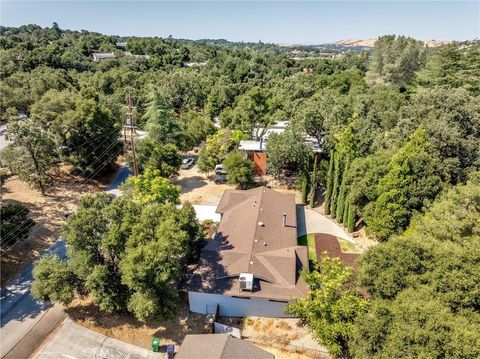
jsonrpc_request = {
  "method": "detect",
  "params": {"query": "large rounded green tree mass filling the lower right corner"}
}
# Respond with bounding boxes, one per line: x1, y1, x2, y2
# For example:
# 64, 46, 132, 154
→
352, 173, 480, 358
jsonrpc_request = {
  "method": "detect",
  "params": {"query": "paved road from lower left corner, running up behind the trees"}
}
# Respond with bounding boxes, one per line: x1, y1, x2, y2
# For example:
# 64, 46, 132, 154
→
0, 166, 130, 358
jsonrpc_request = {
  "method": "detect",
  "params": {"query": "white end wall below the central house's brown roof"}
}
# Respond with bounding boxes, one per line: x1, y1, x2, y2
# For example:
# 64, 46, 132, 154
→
188, 292, 288, 318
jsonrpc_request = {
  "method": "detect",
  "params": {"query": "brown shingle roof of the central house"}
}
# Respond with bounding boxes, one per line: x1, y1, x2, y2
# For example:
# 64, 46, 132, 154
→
187, 187, 308, 301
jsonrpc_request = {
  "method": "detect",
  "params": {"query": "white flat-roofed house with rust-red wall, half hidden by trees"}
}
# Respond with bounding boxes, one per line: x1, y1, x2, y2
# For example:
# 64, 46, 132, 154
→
238, 121, 321, 176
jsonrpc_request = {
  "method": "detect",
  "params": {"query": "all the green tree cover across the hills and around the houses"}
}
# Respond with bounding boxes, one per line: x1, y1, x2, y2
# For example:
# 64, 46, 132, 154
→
0, 24, 480, 358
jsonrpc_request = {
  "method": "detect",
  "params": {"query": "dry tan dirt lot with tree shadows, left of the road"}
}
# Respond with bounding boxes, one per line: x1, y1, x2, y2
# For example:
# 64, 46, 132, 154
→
0, 168, 115, 286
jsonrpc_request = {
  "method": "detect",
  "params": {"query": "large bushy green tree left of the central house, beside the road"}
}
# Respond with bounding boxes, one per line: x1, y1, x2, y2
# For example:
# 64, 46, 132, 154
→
32, 194, 199, 321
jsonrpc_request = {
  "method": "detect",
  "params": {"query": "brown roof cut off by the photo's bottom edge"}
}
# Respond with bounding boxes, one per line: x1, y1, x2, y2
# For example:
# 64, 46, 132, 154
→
175, 334, 275, 359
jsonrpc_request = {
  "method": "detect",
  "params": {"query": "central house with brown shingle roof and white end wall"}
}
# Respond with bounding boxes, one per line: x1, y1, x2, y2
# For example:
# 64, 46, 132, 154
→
185, 187, 308, 318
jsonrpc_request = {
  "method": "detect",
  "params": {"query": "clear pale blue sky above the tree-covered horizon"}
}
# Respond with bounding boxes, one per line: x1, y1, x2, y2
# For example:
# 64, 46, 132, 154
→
0, 0, 480, 44
